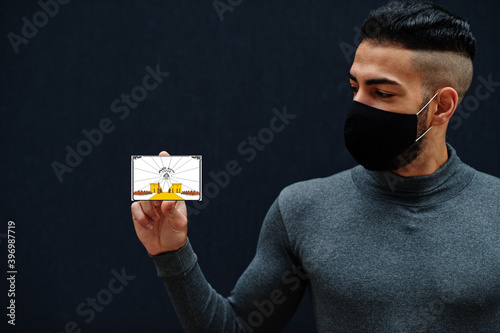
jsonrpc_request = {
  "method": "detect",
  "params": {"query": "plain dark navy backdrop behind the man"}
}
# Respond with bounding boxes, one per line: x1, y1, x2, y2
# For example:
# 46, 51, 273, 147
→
0, 0, 500, 332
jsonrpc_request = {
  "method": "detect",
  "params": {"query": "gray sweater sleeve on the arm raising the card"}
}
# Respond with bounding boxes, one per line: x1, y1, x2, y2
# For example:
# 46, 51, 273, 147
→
151, 200, 307, 333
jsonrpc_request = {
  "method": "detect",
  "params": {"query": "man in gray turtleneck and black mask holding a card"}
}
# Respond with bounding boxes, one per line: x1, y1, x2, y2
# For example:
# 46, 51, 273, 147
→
132, 2, 500, 332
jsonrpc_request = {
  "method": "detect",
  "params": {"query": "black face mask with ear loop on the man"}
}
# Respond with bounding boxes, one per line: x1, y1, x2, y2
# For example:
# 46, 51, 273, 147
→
344, 93, 438, 171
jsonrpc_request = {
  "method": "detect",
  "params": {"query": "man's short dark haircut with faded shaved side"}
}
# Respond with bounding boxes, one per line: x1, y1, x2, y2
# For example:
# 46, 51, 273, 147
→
361, 1, 476, 103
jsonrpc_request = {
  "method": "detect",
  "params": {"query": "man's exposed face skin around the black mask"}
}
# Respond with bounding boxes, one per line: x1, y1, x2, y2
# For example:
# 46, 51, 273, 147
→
349, 41, 429, 170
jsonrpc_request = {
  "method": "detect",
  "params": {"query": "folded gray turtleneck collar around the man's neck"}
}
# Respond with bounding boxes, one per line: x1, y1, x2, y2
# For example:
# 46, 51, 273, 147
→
351, 144, 476, 206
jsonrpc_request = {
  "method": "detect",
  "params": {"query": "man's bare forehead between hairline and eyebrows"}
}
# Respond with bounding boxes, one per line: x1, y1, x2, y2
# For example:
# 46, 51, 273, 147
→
350, 41, 421, 86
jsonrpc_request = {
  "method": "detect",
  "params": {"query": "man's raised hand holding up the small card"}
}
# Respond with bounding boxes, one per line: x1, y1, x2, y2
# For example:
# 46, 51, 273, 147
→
131, 151, 187, 255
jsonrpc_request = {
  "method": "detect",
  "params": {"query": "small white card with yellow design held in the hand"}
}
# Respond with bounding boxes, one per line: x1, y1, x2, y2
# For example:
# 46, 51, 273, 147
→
131, 155, 201, 201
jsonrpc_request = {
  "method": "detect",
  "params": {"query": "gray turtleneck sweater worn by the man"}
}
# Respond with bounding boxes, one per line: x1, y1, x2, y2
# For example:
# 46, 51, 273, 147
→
152, 146, 500, 333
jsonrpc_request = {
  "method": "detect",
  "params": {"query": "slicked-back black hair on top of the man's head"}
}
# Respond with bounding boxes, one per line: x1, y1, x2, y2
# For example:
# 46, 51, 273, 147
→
361, 1, 476, 60
